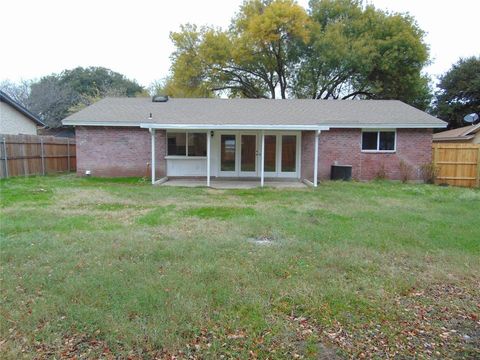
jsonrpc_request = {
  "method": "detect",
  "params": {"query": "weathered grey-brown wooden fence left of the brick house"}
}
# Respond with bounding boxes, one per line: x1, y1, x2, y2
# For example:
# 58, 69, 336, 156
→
0, 134, 77, 178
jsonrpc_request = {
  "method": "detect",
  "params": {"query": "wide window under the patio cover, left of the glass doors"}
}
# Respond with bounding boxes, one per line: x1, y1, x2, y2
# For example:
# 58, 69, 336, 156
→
167, 132, 207, 157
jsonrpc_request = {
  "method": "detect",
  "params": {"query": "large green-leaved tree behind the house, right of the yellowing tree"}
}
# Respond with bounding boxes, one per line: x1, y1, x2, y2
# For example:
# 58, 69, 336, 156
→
293, 0, 430, 108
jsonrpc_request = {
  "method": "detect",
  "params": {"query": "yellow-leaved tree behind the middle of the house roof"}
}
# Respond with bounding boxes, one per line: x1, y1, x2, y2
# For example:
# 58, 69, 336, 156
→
170, 0, 309, 98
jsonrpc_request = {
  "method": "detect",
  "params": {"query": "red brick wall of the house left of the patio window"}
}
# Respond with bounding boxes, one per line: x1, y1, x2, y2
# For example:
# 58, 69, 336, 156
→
75, 126, 166, 177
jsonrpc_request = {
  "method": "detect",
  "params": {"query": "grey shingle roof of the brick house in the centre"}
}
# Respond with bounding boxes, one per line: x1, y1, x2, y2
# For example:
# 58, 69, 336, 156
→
63, 98, 446, 129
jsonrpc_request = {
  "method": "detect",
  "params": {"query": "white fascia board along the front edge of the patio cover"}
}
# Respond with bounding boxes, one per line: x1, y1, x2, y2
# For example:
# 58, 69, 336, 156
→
140, 123, 329, 130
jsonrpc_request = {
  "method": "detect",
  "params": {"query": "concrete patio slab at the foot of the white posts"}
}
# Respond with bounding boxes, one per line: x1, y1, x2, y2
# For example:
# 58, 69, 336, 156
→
160, 179, 307, 189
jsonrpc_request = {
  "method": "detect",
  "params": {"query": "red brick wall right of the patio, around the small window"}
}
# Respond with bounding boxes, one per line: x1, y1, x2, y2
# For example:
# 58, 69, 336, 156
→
302, 129, 432, 180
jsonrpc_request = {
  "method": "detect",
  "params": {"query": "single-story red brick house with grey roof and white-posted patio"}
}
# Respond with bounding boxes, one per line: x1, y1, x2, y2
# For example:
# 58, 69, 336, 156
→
63, 97, 446, 186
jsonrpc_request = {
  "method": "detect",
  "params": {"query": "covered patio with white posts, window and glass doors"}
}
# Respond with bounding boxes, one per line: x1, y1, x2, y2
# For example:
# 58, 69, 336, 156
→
141, 123, 328, 189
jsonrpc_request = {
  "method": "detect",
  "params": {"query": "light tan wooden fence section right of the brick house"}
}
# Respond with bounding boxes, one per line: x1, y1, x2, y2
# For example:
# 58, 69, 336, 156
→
432, 143, 480, 187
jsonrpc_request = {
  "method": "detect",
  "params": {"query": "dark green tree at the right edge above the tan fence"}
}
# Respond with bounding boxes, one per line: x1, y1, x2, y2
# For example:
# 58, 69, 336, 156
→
435, 56, 480, 128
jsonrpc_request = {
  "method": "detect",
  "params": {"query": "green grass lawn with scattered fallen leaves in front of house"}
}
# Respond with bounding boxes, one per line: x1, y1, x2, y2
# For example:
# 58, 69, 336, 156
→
0, 175, 480, 359
